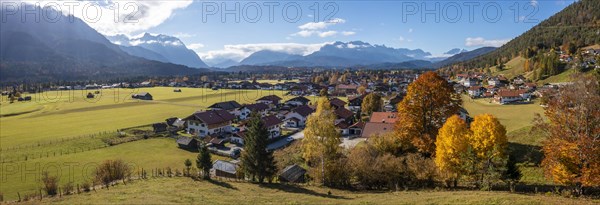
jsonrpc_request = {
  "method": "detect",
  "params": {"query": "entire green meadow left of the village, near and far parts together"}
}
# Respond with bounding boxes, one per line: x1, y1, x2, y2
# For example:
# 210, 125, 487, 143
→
0, 87, 308, 199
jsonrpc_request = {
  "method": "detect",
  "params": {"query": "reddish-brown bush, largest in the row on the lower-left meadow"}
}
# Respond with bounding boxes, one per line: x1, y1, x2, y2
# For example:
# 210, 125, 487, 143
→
95, 160, 131, 188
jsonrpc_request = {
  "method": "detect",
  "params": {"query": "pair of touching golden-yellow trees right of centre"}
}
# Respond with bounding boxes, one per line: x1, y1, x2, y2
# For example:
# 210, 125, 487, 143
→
435, 114, 508, 188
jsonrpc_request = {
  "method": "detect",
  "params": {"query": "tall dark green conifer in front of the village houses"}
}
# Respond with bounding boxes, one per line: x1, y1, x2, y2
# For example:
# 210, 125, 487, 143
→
241, 112, 277, 183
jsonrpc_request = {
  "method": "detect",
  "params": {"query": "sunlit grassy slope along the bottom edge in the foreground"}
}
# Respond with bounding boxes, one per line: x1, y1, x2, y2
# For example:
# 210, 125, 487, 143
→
29, 177, 600, 204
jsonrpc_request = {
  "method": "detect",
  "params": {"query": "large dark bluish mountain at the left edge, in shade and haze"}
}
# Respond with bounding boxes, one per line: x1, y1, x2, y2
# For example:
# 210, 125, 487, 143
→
0, 5, 207, 82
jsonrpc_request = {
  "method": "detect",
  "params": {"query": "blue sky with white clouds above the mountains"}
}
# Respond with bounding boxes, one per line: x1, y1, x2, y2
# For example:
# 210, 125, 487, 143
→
17, 0, 574, 63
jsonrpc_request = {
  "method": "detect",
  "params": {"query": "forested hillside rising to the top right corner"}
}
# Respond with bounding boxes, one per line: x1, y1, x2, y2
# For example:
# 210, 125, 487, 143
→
452, 0, 600, 69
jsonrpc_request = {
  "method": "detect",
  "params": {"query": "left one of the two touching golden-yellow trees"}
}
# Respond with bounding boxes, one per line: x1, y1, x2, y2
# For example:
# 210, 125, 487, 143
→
435, 115, 470, 187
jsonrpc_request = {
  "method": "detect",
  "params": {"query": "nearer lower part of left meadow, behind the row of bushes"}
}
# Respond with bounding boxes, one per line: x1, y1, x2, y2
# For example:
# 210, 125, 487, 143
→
0, 138, 225, 200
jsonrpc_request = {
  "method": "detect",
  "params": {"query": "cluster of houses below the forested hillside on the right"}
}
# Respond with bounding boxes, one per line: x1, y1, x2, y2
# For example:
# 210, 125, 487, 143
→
453, 73, 537, 105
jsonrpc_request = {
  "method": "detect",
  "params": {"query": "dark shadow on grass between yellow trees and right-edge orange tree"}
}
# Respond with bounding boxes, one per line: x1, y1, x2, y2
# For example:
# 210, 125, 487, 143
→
508, 142, 544, 166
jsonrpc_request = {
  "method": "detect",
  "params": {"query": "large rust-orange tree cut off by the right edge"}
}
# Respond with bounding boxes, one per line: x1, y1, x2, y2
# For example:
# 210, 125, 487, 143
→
535, 77, 600, 194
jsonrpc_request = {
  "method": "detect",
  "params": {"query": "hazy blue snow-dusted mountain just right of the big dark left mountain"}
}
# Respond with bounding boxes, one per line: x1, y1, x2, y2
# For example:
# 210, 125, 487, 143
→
107, 33, 209, 68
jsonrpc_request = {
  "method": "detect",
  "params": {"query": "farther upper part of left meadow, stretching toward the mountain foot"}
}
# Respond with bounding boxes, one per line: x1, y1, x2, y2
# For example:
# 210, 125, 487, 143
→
0, 87, 298, 149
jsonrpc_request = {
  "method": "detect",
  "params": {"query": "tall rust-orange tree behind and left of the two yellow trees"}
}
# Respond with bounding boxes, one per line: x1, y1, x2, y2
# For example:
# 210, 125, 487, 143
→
396, 72, 462, 156
